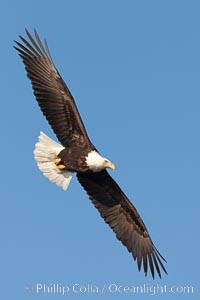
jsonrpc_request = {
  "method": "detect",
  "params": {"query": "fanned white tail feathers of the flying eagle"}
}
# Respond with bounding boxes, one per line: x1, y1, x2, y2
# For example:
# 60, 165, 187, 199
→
34, 132, 73, 190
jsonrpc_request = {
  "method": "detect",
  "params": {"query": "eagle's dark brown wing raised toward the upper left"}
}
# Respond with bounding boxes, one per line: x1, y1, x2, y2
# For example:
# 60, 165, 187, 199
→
15, 30, 90, 147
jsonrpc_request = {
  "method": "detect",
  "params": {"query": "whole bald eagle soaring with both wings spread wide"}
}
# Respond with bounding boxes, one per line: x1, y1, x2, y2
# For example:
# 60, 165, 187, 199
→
15, 30, 167, 278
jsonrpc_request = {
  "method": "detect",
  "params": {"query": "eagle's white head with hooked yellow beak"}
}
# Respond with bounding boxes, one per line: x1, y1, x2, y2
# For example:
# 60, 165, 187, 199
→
86, 150, 115, 172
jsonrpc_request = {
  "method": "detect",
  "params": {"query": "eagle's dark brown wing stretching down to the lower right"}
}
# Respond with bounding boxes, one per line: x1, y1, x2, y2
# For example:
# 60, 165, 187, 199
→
77, 170, 167, 278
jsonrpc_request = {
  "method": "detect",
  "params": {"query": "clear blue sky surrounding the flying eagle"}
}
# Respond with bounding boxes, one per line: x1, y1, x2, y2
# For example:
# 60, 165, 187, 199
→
0, 0, 200, 300
